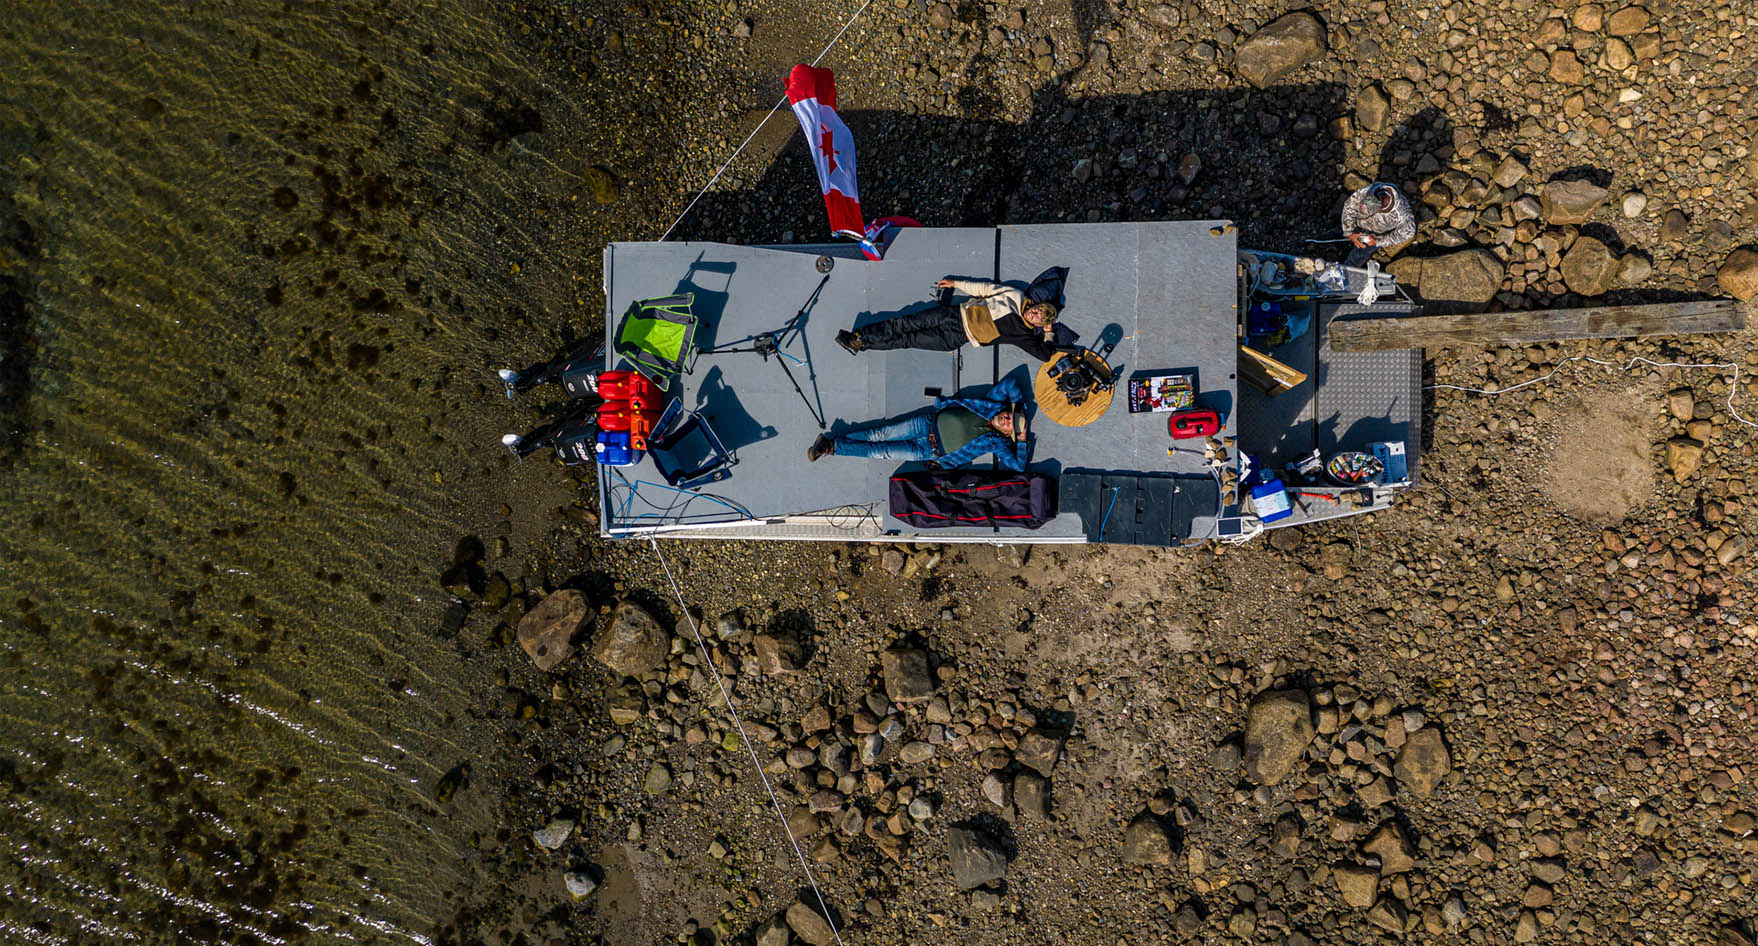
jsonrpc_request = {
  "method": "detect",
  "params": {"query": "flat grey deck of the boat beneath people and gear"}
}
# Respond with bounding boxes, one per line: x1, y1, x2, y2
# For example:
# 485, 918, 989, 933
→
599, 220, 1420, 545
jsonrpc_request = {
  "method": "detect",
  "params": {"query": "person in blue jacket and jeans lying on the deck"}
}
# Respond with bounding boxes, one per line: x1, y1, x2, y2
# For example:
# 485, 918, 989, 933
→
805, 371, 1034, 471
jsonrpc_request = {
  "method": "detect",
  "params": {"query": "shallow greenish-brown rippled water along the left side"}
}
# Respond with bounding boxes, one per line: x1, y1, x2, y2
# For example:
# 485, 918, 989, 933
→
0, 0, 671, 942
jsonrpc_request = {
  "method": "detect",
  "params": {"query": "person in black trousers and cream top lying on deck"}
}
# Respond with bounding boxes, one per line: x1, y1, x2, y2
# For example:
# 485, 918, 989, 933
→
837, 276, 1057, 360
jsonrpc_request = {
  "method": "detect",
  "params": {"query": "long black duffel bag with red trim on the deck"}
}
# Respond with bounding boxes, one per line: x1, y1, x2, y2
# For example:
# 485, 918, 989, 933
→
891, 469, 1057, 529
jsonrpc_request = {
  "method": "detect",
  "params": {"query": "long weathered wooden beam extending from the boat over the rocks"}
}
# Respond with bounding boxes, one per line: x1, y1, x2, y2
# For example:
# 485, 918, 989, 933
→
1329, 299, 1746, 352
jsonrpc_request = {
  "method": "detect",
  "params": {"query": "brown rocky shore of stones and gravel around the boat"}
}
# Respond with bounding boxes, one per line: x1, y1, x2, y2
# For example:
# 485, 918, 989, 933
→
432, 0, 1758, 946
